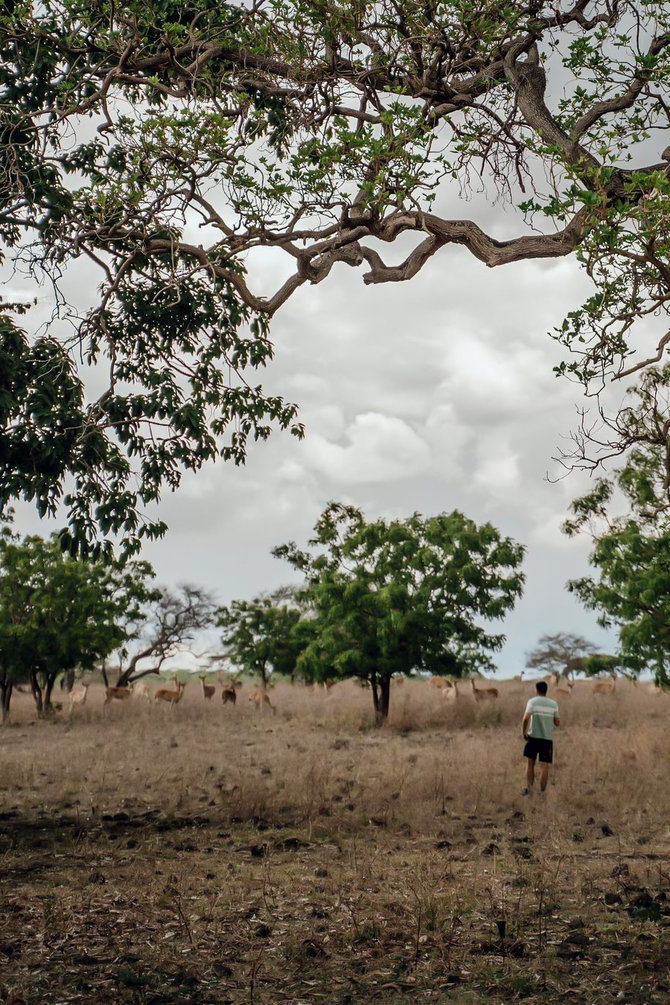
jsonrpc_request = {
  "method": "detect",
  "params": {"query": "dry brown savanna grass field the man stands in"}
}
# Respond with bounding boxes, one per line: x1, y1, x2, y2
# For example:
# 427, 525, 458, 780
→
0, 681, 670, 1003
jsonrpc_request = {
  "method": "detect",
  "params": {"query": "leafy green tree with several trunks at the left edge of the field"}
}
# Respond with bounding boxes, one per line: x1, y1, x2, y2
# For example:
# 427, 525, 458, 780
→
0, 529, 153, 720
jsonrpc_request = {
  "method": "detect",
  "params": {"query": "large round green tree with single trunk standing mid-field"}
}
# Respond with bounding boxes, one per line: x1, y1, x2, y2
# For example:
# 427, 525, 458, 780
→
273, 503, 523, 722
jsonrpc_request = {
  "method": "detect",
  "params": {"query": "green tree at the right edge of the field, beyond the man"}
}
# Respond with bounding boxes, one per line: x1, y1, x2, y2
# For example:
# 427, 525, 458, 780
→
565, 367, 670, 685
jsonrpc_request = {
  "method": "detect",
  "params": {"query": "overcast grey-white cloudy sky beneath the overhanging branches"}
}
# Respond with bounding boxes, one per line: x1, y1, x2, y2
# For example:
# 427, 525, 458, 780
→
6, 174, 614, 676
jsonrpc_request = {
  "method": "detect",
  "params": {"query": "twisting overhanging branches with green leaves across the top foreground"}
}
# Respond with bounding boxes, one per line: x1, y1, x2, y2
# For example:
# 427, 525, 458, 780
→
0, 0, 670, 547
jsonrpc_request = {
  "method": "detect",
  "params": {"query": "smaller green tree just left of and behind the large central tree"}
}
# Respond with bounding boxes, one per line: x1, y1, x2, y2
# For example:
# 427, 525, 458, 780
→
216, 597, 312, 687
